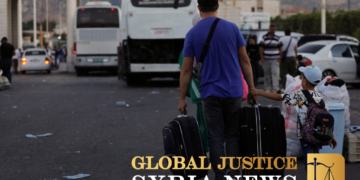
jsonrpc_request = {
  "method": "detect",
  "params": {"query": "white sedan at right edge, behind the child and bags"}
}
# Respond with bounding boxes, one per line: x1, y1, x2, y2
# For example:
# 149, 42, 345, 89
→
298, 41, 360, 87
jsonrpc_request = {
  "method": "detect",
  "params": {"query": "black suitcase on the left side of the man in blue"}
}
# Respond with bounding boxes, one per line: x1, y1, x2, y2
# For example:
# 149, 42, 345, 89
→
163, 115, 209, 179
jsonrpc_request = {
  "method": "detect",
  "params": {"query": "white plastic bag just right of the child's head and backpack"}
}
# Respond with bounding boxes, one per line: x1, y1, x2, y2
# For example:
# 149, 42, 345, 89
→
315, 76, 350, 132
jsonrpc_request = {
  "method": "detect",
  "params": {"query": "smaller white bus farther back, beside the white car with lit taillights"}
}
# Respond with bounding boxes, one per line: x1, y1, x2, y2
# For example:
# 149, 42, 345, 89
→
73, 1, 121, 75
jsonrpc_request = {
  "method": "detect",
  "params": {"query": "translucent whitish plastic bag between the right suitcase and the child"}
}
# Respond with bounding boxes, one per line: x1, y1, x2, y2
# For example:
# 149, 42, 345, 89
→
281, 74, 302, 157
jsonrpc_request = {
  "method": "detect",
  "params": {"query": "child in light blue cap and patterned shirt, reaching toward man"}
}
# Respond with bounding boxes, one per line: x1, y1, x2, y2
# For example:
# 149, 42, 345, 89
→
250, 65, 337, 168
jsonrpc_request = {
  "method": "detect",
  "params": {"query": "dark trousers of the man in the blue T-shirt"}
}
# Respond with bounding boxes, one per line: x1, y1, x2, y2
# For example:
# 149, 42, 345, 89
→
202, 96, 242, 180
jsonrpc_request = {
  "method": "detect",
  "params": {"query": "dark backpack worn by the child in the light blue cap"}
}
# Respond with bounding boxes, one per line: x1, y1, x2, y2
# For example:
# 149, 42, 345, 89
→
301, 90, 334, 146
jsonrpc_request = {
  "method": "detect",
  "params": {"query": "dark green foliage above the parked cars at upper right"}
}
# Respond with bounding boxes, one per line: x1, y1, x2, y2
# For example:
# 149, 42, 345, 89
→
271, 11, 360, 39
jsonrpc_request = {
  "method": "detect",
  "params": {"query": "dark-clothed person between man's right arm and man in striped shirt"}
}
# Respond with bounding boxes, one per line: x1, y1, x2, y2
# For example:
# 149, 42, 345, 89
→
246, 36, 260, 86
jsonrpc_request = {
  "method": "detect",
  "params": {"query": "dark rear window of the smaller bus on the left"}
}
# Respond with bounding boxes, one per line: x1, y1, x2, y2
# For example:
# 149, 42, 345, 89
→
76, 8, 119, 28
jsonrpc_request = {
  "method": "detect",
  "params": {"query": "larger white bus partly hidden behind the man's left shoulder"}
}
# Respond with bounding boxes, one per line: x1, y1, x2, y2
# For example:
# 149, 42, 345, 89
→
118, 0, 198, 85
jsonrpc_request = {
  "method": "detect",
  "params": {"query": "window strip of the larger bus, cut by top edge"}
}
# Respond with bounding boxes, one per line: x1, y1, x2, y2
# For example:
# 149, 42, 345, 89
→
131, 0, 191, 7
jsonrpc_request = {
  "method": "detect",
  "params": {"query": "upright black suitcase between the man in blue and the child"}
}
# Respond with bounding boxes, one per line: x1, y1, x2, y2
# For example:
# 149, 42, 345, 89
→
240, 105, 286, 176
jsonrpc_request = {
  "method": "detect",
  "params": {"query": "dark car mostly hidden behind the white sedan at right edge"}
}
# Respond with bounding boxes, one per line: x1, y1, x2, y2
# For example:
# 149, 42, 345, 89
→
298, 34, 359, 47
